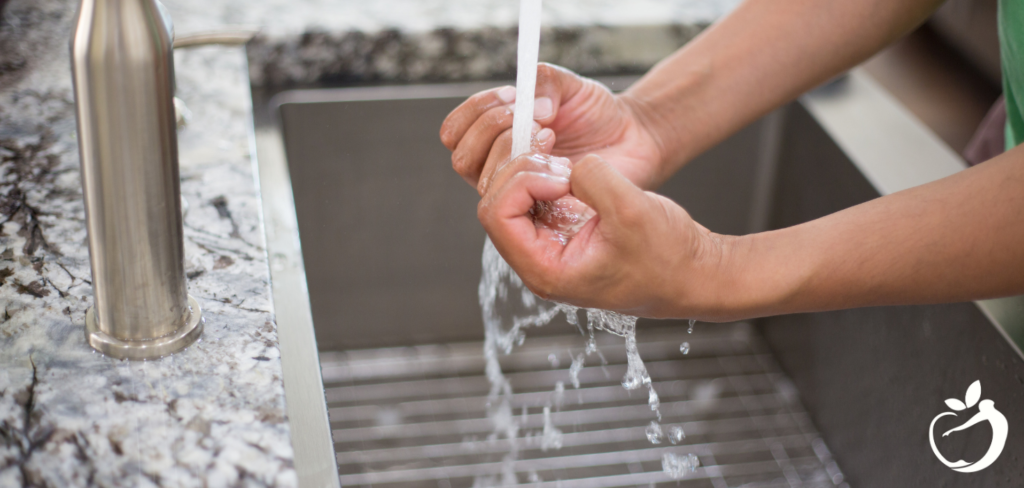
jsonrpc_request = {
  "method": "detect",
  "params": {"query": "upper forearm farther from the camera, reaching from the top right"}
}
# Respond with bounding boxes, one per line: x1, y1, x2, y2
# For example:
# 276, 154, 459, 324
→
623, 0, 941, 184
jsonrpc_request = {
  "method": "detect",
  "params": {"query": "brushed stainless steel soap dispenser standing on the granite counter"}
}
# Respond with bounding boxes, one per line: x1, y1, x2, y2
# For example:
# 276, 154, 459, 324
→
71, 0, 203, 359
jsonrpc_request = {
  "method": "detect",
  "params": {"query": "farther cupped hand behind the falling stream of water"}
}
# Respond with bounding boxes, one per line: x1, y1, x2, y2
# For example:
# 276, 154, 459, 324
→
440, 63, 664, 195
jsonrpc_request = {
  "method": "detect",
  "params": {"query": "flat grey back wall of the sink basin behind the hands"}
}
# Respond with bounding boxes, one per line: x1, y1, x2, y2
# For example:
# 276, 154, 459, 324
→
275, 77, 758, 350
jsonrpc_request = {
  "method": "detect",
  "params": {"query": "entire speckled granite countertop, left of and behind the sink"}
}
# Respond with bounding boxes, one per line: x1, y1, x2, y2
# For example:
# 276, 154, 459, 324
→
0, 0, 738, 486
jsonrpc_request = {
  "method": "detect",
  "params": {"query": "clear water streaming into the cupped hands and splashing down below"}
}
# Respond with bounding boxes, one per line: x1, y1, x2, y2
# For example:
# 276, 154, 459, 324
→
474, 0, 675, 486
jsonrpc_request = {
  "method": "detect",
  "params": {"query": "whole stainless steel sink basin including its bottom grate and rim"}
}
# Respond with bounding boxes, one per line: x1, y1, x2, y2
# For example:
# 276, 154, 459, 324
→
256, 72, 1024, 488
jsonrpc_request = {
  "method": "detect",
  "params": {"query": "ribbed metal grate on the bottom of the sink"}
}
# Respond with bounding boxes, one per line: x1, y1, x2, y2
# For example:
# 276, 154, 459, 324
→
321, 323, 845, 488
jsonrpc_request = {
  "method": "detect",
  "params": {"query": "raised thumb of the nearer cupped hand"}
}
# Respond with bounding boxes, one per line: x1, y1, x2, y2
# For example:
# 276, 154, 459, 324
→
569, 154, 644, 220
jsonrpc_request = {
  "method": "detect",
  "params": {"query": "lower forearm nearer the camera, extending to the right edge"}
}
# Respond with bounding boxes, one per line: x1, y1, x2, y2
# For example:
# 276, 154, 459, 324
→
712, 144, 1024, 319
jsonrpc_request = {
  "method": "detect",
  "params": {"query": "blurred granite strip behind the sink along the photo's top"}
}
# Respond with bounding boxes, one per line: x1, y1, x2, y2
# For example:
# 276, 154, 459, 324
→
165, 0, 739, 85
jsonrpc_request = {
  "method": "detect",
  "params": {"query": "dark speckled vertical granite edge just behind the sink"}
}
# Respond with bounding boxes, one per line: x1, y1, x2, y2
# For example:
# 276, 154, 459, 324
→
248, 25, 707, 87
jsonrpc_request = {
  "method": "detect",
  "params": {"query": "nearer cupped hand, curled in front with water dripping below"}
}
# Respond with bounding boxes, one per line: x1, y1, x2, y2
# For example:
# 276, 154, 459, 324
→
477, 152, 730, 319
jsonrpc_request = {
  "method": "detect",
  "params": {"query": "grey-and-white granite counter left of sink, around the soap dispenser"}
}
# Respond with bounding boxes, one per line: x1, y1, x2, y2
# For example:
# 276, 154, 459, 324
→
0, 0, 296, 487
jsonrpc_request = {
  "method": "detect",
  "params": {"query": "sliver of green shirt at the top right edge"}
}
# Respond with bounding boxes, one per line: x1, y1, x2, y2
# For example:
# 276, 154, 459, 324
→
999, 0, 1024, 150
